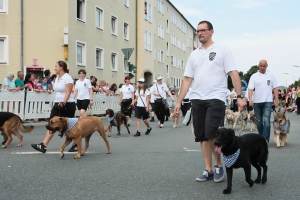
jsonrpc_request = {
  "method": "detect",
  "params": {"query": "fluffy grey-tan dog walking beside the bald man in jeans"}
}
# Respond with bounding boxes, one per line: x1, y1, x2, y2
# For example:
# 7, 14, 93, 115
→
273, 109, 291, 147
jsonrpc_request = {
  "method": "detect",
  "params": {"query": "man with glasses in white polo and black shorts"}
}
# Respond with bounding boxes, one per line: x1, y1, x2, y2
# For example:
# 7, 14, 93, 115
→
174, 21, 246, 182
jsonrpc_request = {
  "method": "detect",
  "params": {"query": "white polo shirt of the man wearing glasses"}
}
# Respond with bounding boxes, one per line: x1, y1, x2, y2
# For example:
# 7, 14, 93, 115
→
184, 43, 237, 102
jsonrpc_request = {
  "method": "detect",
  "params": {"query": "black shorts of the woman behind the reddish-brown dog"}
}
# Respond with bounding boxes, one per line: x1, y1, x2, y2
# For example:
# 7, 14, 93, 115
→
50, 102, 76, 119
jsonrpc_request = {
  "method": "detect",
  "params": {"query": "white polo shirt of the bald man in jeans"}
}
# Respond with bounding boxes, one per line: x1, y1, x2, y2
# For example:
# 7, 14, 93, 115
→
248, 71, 278, 103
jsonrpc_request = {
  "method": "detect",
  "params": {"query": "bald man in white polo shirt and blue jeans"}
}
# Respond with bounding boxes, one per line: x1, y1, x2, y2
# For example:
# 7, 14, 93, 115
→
248, 60, 278, 142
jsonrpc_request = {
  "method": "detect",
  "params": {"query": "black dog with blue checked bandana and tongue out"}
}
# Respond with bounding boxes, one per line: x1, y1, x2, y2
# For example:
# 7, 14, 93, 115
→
215, 128, 269, 194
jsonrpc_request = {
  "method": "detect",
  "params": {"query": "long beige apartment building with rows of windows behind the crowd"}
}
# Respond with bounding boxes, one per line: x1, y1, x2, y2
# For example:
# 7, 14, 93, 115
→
0, 0, 197, 87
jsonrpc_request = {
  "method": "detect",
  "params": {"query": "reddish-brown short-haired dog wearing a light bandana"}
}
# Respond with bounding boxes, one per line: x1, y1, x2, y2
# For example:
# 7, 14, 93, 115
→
46, 116, 111, 159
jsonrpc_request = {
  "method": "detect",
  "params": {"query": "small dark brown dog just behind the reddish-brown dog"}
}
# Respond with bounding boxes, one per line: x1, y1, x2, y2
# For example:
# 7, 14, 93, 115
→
105, 109, 130, 137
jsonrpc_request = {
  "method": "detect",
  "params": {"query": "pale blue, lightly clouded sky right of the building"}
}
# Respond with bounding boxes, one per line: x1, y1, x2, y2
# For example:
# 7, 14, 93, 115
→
170, 0, 300, 86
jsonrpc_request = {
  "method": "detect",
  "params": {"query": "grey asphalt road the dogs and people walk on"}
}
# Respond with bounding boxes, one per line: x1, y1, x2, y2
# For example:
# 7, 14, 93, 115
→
0, 113, 300, 200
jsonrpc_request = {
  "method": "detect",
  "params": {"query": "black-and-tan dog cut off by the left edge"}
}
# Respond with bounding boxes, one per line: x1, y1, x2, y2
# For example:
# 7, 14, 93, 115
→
0, 112, 34, 148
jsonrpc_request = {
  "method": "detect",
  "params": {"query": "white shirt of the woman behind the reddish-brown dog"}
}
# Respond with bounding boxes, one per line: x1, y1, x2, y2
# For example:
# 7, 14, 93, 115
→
53, 73, 75, 102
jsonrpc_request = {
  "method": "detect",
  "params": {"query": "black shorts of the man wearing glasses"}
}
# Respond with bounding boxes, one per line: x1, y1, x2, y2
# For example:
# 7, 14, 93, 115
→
191, 99, 225, 142
